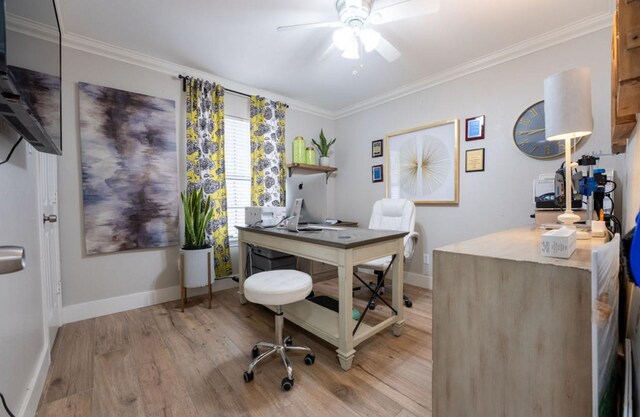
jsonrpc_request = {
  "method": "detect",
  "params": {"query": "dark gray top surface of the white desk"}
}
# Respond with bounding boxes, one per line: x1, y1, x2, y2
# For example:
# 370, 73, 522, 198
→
236, 226, 408, 249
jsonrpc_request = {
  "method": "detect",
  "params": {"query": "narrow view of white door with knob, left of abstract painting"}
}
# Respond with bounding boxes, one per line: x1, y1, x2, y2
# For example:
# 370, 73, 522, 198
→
38, 152, 62, 349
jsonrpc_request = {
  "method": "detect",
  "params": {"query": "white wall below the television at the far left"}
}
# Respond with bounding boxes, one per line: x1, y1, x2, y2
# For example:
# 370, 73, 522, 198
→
0, 121, 46, 416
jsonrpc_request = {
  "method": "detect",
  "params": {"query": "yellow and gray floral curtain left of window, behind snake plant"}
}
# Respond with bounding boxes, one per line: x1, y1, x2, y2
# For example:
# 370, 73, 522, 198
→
186, 78, 231, 277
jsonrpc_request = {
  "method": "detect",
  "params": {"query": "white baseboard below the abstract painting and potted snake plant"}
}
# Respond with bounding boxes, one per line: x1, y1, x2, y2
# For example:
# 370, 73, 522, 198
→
62, 279, 238, 324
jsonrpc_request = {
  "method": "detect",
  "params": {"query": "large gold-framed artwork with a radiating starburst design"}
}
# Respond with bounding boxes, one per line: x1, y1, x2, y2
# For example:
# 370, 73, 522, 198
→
385, 119, 460, 204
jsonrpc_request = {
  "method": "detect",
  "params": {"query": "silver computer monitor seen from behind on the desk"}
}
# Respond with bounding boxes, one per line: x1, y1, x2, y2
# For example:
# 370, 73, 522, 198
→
286, 173, 327, 223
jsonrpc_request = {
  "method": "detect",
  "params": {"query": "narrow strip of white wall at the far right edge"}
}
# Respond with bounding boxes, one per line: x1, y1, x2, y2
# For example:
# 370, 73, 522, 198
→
622, 125, 640, 233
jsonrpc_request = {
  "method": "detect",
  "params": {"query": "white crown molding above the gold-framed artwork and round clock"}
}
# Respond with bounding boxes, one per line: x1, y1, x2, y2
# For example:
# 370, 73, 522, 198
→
333, 12, 613, 120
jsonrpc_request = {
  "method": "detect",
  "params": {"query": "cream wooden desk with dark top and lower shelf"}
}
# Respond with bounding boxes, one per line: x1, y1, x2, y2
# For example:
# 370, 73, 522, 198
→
238, 227, 407, 371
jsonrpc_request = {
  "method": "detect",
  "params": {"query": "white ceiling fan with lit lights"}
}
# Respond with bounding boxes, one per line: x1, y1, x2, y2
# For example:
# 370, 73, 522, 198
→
278, 0, 438, 62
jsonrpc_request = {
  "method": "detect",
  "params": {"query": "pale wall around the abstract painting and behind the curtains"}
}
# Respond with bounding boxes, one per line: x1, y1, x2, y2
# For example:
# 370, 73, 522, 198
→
59, 48, 333, 314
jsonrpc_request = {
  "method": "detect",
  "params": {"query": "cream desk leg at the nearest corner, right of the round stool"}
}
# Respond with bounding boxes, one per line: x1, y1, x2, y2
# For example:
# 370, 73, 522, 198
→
336, 249, 356, 371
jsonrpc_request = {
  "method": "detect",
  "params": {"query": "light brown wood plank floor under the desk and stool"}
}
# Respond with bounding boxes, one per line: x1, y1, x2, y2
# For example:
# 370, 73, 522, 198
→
37, 280, 432, 417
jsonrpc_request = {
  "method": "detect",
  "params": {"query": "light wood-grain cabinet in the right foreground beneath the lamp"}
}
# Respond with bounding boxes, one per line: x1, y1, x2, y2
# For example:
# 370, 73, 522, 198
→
433, 228, 603, 417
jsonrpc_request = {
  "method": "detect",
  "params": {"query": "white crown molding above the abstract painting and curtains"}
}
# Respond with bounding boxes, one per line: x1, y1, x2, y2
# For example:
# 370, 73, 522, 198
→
62, 32, 333, 119
